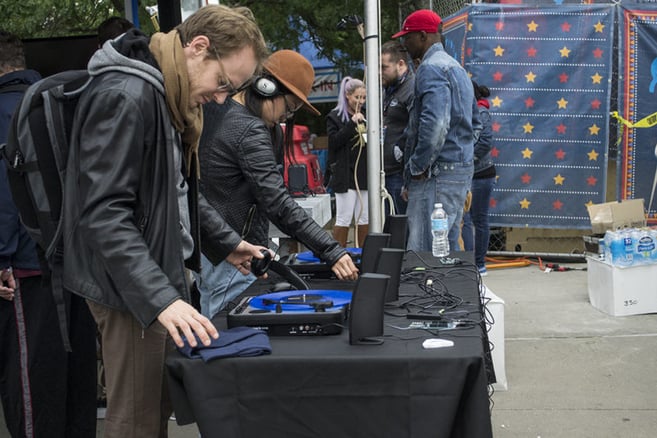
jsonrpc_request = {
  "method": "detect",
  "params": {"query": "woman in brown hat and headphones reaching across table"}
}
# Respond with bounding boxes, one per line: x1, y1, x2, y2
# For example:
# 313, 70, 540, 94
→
197, 50, 358, 318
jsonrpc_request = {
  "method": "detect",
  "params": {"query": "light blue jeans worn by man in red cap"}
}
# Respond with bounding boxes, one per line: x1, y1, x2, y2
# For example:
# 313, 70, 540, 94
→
406, 162, 473, 251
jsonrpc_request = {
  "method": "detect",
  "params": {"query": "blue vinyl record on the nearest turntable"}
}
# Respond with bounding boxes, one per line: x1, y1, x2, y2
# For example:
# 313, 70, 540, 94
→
249, 289, 351, 312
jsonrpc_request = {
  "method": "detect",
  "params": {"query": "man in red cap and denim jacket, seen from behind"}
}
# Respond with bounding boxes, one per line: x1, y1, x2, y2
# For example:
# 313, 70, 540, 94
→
392, 9, 481, 251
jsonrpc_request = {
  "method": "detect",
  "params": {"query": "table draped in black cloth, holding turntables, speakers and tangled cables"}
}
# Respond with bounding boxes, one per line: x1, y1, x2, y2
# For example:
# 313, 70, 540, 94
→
166, 253, 492, 438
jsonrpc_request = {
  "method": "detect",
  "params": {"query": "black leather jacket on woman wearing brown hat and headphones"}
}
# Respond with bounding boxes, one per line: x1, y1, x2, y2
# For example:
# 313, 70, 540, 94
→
199, 99, 346, 265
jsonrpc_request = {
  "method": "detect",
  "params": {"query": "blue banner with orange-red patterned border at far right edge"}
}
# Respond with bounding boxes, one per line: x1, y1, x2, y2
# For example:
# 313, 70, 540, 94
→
618, 3, 657, 225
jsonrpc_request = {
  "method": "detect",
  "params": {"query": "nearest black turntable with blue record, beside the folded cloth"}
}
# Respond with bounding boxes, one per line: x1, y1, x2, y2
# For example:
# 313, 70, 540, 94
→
228, 289, 351, 336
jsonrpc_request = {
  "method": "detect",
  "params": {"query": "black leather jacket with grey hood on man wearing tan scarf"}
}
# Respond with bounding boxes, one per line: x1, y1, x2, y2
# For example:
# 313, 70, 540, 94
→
64, 30, 241, 326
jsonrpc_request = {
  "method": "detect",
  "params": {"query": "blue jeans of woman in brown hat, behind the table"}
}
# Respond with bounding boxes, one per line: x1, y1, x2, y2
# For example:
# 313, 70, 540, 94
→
194, 255, 256, 318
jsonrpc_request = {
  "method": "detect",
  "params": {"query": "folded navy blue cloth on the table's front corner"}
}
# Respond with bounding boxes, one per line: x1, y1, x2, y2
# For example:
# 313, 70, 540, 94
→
177, 327, 271, 362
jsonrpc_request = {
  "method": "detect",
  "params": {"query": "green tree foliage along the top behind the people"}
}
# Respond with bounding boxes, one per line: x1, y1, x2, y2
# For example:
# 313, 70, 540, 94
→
0, 0, 436, 69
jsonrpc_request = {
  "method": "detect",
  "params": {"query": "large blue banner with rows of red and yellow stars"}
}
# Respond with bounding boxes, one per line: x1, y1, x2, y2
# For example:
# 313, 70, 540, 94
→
465, 4, 614, 229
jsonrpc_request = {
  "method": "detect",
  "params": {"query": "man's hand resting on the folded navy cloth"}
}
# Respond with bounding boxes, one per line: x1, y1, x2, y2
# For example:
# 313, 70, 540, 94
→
157, 299, 219, 347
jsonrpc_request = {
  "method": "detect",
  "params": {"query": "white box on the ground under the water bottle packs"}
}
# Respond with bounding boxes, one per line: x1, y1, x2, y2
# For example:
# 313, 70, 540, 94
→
586, 257, 657, 316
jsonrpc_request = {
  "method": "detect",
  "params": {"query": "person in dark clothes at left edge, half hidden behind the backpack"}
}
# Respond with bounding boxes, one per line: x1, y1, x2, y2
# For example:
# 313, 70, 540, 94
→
0, 31, 96, 438
